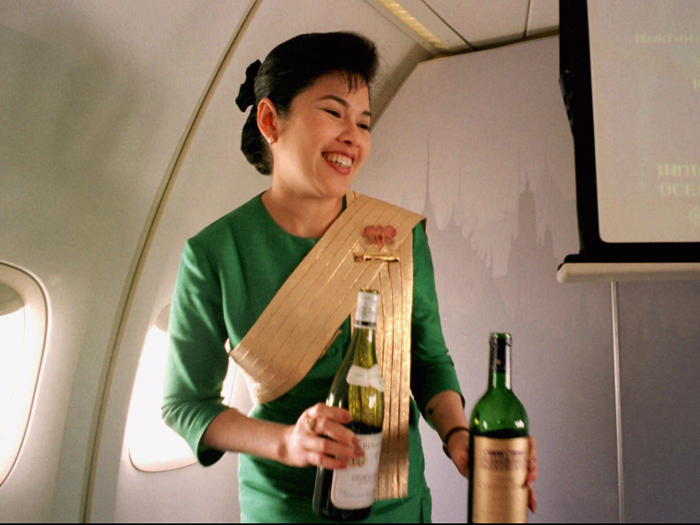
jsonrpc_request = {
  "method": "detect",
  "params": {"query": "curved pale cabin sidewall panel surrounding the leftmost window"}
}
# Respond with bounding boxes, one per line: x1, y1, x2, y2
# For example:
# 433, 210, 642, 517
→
0, 0, 244, 521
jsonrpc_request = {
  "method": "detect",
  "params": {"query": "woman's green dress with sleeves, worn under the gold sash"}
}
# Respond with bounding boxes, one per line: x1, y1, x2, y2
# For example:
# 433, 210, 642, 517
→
163, 195, 460, 523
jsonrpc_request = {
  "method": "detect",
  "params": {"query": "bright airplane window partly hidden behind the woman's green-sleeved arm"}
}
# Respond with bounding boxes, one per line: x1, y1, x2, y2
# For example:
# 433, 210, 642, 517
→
126, 304, 236, 472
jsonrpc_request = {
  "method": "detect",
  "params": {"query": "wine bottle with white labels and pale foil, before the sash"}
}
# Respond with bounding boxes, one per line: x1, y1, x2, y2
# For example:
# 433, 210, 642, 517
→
313, 290, 384, 521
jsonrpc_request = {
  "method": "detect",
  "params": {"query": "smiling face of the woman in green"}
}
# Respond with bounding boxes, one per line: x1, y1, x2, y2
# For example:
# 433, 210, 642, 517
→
272, 74, 372, 199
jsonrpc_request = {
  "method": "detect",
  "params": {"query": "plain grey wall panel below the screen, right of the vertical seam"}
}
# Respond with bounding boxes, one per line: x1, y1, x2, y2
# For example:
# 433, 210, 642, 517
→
617, 281, 700, 523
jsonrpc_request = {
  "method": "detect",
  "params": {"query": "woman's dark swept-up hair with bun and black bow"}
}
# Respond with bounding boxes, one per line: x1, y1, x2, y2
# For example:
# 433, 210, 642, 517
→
236, 32, 379, 175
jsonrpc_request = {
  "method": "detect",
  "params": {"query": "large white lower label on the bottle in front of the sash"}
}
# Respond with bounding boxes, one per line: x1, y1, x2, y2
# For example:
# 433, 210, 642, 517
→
331, 432, 382, 510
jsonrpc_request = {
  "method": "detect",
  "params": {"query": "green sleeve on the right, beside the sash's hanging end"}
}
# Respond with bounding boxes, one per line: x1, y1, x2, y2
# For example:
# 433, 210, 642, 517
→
411, 223, 464, 419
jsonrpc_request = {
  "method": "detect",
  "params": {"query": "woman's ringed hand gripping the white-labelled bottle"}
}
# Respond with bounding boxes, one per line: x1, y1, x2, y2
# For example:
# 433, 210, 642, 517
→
280, 403, 364, 469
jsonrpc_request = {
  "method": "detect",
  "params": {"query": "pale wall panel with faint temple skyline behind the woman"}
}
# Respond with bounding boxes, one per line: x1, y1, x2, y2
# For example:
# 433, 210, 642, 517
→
357, 38, 618, 522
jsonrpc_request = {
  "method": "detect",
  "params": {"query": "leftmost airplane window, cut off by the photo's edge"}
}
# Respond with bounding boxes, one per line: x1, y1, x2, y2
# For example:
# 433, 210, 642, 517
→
0, 263, 47, 484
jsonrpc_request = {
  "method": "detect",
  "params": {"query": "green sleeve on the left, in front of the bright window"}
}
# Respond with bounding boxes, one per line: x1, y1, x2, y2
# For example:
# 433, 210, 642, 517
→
162, 240, 228, 466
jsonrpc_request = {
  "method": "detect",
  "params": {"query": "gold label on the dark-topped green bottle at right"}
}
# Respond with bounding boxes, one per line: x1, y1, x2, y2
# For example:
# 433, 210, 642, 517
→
471, 436, 529, 523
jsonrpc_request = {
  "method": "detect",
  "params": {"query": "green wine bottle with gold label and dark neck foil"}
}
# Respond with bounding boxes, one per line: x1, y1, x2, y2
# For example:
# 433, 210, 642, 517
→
467, 333, 529, 523
